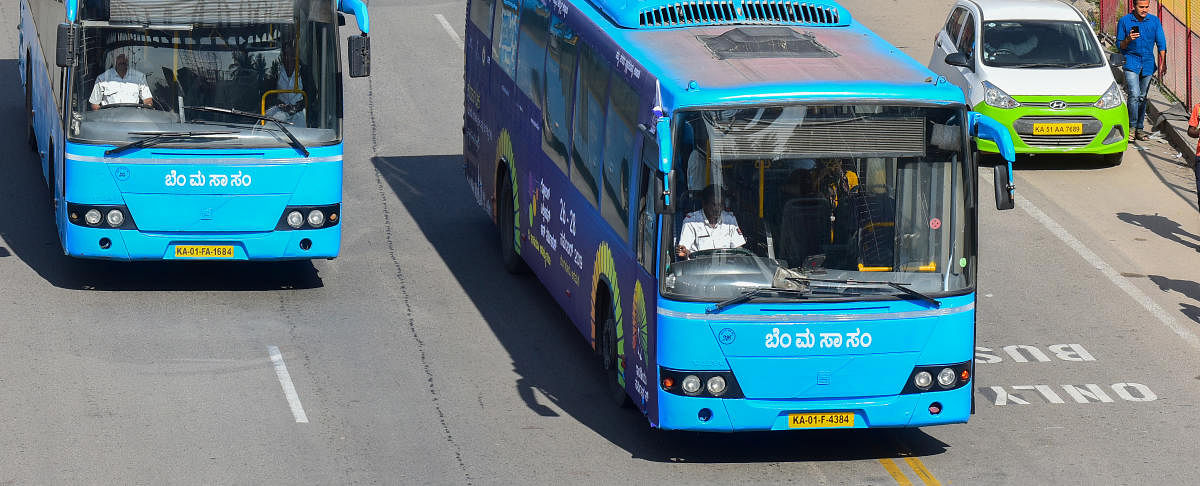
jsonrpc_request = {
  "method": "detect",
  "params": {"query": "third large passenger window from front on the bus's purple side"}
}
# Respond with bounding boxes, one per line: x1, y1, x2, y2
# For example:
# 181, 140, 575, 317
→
541, 16, 580, 174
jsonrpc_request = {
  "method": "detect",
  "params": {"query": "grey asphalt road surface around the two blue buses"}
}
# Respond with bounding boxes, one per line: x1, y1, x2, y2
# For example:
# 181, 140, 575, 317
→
0, 0, 1200, 485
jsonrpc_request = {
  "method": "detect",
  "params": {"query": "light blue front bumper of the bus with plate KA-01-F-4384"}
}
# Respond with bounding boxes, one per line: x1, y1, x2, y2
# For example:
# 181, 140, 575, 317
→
658, 379, 974, 432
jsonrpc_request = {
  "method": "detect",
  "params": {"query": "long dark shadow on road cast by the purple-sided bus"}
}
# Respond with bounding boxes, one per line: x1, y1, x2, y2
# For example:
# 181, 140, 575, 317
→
372, 155, 947, 463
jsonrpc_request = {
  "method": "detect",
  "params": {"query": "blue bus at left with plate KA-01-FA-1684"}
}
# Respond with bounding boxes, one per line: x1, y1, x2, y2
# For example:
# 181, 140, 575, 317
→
18, 0, 370, 260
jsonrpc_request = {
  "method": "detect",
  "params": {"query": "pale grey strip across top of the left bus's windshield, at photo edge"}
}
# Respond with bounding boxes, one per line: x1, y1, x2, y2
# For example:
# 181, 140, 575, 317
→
108, 0, 295, 25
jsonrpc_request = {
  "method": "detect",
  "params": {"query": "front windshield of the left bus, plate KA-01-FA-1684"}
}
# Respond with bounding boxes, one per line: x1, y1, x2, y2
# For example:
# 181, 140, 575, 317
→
68, 16, 341, 148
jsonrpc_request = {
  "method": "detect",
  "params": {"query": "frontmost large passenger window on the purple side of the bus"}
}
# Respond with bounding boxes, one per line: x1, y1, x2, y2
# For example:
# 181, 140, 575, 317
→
600, 72, 637, 241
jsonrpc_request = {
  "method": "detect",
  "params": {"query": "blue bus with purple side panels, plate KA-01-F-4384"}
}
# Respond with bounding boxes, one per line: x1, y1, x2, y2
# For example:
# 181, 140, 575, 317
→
463, 0, 1014, 432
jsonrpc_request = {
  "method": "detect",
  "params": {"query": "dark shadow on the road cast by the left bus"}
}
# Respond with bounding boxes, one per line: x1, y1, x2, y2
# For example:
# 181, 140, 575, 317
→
0, 59, 322, 290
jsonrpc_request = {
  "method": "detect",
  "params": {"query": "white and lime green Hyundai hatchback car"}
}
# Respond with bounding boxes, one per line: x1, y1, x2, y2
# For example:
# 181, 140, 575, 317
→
929, 0, 1129, 164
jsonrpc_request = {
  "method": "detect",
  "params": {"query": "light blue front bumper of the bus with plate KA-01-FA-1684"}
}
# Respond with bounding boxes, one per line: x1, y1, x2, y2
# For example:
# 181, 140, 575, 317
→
64, 224, 342, 260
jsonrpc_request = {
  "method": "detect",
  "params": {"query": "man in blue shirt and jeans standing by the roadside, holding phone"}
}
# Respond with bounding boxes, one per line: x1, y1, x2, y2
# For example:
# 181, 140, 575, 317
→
1117, 0, 1166, 142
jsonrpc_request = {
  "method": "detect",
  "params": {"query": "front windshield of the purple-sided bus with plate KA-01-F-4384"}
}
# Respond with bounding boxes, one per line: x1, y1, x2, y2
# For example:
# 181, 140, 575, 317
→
662, 104, 974, 301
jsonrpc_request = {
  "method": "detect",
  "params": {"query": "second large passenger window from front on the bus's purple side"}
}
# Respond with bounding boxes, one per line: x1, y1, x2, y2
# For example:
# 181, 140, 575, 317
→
571, 44, 608, 206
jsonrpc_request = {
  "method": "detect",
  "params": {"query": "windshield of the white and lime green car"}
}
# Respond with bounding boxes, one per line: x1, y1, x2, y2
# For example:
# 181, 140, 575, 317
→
982, 20, 1104, 68
